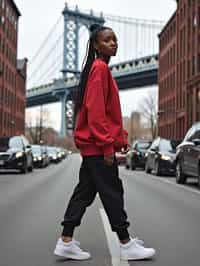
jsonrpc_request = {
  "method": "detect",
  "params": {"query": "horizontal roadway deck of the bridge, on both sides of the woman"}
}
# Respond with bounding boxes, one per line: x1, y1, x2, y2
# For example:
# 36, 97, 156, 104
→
26, 55, 158, 107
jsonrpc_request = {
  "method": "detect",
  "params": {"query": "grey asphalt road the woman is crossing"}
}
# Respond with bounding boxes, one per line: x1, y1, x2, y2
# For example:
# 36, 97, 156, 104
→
0, 155, 200, 266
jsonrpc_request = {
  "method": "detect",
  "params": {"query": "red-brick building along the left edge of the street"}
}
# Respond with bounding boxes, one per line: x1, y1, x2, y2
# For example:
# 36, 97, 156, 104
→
0, 0, 27, 136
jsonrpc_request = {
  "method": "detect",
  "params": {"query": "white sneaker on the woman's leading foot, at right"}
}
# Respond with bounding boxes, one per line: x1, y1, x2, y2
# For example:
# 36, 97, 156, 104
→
120, 239, 156, 260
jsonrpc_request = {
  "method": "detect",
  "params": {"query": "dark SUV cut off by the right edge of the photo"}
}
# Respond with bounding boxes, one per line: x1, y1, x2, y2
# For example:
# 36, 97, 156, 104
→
176, 122, 200, 187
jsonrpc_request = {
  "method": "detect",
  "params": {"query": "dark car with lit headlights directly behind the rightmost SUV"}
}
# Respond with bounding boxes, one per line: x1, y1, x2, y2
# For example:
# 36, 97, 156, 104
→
145, 137, 180, 176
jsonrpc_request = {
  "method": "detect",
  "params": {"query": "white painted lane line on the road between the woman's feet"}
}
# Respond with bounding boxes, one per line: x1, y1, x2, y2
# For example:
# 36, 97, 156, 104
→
99, 208, 129, 266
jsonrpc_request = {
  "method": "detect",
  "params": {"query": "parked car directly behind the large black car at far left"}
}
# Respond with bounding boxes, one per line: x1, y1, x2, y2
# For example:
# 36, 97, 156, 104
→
31, 145, 49, 167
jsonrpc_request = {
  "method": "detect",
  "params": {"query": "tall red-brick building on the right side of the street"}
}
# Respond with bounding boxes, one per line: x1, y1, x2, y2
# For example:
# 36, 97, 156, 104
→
158, 0, 200, 139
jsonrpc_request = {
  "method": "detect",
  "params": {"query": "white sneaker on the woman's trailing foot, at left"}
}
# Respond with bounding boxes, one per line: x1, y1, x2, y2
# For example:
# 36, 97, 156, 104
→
54, 238, 91, 260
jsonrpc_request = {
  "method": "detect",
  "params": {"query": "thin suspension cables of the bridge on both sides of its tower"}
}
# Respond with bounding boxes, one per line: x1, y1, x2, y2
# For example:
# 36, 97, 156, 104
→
28, 7, 164, 88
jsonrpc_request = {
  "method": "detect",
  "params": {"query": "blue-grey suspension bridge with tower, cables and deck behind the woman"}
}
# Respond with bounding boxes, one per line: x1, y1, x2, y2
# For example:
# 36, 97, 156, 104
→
26, 4, 164, 137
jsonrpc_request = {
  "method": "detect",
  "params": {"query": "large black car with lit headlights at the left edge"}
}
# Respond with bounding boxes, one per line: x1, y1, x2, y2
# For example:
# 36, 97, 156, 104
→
0, 136, 33, 173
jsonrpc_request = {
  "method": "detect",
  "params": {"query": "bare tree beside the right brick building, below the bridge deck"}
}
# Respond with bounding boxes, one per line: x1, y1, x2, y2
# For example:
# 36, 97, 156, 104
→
139, 91, 158, 139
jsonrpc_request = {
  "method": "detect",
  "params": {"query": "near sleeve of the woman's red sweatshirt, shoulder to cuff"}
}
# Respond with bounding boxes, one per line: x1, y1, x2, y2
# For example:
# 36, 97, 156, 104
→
86, 64, 114, 154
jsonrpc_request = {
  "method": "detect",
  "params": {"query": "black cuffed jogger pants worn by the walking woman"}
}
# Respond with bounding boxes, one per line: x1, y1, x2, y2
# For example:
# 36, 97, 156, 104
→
61, 155, 129, 240
